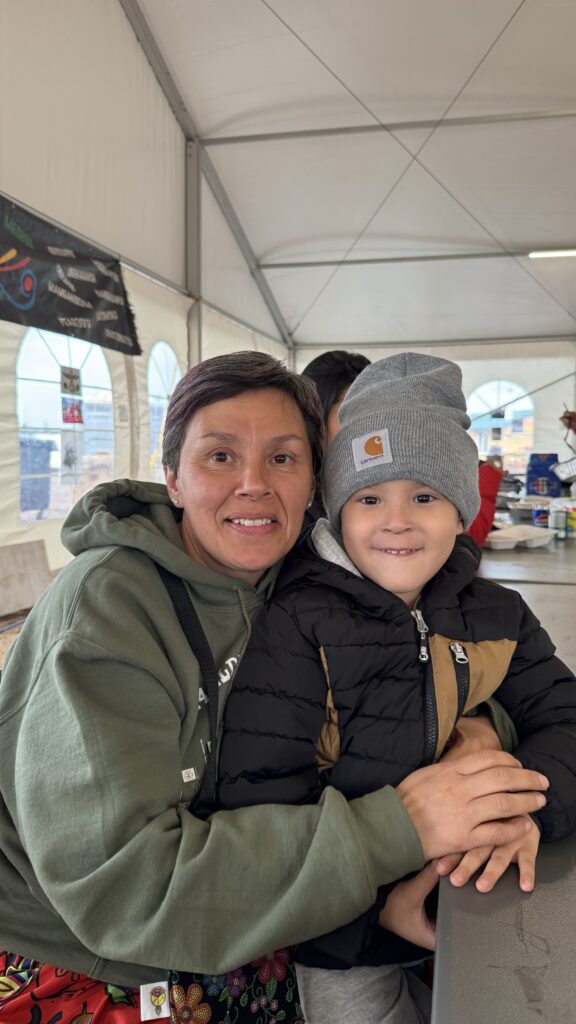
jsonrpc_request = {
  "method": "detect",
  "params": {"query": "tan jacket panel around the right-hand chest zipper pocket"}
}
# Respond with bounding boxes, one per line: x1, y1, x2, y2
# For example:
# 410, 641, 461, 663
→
428, 636, 517, 761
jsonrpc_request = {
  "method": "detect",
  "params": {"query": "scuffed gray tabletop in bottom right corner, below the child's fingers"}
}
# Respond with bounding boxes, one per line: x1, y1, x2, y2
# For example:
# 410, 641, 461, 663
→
433, 837, 576, 1024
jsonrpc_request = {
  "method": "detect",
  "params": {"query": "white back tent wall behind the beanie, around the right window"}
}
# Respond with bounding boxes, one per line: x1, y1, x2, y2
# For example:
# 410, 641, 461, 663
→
296, 340, 576, 462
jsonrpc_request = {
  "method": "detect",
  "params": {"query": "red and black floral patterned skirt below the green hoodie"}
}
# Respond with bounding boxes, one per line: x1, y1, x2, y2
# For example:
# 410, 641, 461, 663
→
0, 949, 304, 1024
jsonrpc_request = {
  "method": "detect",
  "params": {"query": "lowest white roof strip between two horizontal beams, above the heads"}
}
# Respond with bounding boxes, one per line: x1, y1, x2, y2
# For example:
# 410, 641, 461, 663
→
266, 258, 574, 347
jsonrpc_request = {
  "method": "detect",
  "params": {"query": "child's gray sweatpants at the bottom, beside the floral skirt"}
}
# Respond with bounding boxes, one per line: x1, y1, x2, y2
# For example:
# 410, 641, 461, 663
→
296, 964, 431, 1024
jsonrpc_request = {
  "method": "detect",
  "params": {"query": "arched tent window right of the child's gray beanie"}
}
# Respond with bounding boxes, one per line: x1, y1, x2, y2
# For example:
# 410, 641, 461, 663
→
467, 381, 534, 475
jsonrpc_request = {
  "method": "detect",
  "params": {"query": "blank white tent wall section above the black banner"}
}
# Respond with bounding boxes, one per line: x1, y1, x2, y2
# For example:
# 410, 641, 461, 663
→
0, 0, 186, 286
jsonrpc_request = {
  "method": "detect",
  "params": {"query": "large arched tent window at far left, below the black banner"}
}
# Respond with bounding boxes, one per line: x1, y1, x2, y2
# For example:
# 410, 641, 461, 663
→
16, 328, 114, 522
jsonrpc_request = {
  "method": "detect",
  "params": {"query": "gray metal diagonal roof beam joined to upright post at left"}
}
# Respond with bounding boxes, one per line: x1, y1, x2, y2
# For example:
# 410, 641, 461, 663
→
119, 0, 293, 349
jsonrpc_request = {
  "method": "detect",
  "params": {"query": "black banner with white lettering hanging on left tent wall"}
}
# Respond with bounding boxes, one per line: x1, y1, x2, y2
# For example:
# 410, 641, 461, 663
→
0, 196, 141, 355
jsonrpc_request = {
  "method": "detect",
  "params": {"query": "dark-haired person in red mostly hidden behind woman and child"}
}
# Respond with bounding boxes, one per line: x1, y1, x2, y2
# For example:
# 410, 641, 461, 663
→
302, 349, 502, 548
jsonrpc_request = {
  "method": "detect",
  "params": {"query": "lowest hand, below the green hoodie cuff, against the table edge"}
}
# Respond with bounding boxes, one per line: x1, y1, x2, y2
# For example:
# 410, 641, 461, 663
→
378, 861, 438, 949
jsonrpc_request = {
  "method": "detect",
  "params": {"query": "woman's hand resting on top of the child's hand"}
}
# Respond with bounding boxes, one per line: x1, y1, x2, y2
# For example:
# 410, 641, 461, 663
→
396, 751, 548, 861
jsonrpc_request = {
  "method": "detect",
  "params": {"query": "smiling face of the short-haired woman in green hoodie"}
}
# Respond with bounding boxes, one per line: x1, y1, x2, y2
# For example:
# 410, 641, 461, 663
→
165, 388, 314, 584
